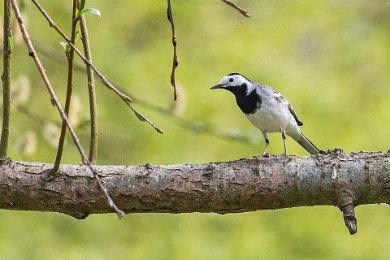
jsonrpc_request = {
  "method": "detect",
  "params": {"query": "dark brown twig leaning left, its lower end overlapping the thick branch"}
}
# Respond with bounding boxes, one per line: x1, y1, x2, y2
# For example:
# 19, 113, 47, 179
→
53, 0, 78, 173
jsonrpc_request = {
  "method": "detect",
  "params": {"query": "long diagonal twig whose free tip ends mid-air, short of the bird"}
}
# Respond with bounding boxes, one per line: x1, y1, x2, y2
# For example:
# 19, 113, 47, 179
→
32, 0, 163, 134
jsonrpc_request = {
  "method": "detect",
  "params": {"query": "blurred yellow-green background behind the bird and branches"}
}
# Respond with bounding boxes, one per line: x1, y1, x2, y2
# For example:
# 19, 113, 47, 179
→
0, 0, 390, 259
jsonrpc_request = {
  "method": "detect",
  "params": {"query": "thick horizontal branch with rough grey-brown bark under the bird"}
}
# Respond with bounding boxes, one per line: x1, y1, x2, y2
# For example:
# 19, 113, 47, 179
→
0, 150, 390, 232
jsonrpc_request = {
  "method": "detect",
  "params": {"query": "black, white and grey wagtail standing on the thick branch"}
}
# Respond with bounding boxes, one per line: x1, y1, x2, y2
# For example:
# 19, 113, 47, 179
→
211, 73, 319, 154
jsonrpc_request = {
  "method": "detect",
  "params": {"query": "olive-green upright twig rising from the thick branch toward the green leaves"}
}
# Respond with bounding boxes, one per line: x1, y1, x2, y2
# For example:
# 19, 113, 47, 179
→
80, 15, 98, 163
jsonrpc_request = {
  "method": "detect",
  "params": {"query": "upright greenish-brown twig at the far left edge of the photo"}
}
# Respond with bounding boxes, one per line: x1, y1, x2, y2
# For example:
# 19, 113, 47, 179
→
0, 0, 12, 159
